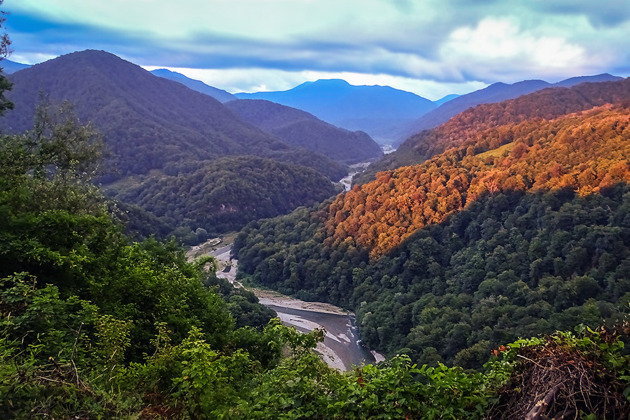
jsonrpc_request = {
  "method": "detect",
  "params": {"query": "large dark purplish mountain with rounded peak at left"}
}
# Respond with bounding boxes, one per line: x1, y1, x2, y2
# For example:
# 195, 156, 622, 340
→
0, 51, 343, 179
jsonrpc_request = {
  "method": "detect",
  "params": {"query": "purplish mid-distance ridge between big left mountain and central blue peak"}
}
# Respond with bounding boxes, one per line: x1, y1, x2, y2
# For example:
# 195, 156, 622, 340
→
226, 99, 383, 164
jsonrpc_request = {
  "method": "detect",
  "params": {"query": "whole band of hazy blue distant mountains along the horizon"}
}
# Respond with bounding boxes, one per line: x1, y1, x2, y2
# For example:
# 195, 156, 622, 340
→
4, 53, 620, 151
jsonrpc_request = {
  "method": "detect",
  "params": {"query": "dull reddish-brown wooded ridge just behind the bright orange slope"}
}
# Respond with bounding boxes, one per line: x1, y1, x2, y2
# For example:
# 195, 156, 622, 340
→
358, 79, 630, 182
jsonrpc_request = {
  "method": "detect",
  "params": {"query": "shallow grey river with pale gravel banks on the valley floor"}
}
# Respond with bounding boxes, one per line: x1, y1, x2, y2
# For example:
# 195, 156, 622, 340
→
211, 246, 384, 371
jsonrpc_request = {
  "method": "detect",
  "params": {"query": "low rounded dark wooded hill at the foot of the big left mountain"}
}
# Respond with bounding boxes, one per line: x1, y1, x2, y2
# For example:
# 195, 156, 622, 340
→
110, 156, 338, 240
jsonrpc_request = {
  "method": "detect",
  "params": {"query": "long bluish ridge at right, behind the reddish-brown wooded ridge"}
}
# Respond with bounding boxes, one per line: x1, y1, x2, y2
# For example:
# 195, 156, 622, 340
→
395, 73, 621, 144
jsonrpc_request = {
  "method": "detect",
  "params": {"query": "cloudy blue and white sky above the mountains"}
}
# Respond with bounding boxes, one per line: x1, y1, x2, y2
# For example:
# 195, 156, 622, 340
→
2, 0, 630, 99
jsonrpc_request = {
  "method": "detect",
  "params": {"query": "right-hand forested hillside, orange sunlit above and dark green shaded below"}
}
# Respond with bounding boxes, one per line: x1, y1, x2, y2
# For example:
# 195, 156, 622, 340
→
235, 105, 630, 367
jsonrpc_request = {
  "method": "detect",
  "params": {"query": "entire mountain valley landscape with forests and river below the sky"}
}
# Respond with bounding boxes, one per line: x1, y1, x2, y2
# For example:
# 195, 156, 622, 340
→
0, 45, 630, 419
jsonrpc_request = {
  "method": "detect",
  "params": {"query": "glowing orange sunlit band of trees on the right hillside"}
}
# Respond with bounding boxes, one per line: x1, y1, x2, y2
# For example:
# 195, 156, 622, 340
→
325, 105, 630, 258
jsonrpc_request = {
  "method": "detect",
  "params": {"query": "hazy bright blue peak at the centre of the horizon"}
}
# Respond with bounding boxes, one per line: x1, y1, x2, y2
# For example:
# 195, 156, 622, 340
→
236, 79, 436, 144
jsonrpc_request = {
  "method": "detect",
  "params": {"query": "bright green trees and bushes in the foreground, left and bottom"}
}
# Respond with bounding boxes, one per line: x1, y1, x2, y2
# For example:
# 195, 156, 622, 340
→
0, 97, 630, 419
